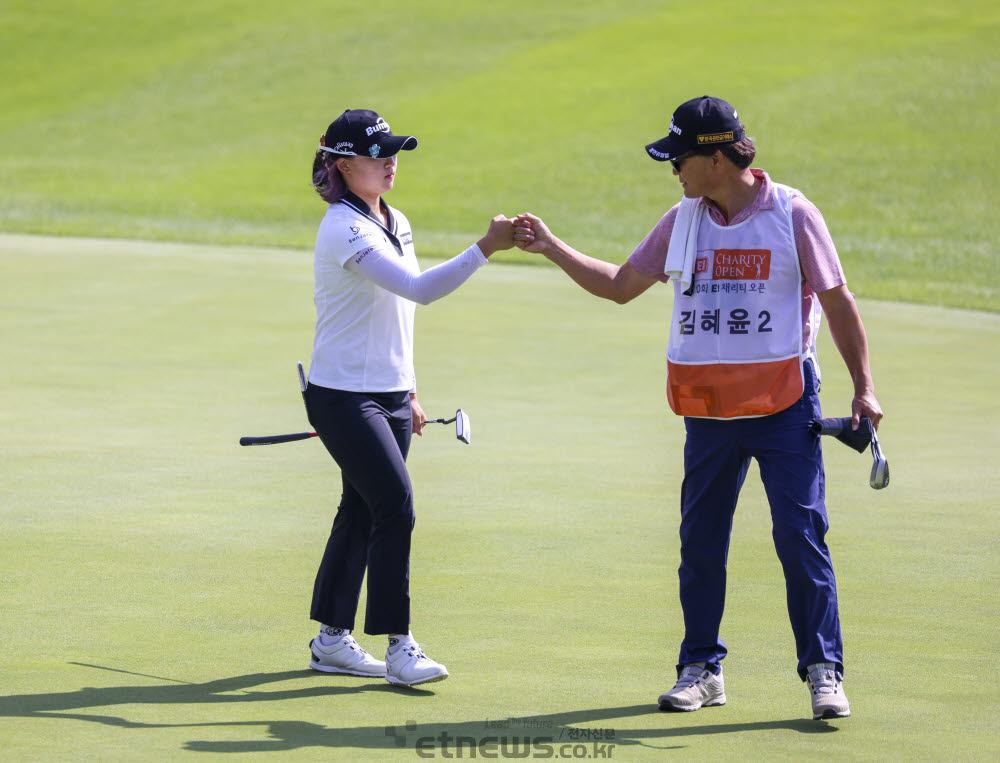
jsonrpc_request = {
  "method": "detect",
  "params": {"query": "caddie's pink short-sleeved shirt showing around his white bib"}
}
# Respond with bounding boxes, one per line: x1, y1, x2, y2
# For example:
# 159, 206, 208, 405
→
628, 169, 847, 356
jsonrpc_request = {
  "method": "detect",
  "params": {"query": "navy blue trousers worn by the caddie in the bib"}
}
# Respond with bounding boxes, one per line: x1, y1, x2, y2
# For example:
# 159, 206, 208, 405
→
678, 361, 844, 679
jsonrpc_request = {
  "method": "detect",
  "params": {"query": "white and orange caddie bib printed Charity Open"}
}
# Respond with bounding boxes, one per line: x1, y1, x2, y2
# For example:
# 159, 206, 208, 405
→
667, 183, 804, 419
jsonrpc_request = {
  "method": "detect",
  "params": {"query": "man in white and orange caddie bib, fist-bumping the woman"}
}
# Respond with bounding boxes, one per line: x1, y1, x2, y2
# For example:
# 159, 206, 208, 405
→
515, 95, 882, 718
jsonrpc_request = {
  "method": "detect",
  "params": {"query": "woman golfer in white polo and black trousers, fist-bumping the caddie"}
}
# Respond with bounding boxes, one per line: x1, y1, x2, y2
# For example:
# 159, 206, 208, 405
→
306, 109, 514, 686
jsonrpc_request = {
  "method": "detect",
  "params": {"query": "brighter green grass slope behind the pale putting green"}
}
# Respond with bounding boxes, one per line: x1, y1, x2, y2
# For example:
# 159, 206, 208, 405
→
0, 0, 1000, 312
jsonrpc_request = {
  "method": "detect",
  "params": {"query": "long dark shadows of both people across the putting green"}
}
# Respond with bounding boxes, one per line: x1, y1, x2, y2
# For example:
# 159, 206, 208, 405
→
0, 663, 837, 758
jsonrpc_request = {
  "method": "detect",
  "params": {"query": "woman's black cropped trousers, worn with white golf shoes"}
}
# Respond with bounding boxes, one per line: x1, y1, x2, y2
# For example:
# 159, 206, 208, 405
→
306, 384, 414, 635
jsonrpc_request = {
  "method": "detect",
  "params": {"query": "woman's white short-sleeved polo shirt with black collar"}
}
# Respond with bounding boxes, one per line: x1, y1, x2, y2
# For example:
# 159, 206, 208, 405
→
309, 193, 420, 392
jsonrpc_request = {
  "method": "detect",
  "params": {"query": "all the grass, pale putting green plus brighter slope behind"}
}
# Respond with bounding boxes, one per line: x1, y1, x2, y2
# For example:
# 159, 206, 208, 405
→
0, 0, 1000, 760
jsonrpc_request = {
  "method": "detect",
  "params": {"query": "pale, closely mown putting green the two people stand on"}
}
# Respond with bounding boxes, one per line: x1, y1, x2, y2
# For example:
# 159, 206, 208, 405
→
0, 235, 1000, 760
